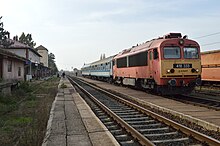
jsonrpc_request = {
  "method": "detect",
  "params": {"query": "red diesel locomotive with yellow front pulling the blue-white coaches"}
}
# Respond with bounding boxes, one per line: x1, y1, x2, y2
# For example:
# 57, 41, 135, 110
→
82, 33, 201, 94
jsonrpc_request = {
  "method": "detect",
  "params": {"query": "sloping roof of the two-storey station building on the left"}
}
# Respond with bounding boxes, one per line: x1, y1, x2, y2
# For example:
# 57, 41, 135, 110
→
5, 39, 42, 57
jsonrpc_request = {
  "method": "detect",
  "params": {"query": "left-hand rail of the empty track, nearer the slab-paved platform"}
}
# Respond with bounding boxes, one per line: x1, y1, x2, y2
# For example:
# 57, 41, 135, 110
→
69, 78, 155, 146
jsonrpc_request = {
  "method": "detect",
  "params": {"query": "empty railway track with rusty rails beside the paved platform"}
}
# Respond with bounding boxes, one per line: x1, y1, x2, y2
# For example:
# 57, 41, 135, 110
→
69, 78, 220, 145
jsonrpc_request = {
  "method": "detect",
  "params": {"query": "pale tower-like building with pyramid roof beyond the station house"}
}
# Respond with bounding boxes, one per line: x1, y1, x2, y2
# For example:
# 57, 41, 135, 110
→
36, 45, 48, 67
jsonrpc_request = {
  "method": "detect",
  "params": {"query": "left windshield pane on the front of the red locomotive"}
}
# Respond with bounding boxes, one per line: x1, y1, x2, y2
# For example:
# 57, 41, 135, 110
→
163, 47, 180, 59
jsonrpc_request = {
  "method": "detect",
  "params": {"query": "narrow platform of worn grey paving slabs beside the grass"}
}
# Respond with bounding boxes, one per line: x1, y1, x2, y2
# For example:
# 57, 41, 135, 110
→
42, 78, 119, 146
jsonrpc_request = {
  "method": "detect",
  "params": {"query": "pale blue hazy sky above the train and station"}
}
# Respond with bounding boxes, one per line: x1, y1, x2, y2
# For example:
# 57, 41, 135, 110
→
0, 0, 220, 70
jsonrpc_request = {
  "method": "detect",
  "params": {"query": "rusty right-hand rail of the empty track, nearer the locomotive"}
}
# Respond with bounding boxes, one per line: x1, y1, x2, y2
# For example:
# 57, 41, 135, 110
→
73, 76, 220, 146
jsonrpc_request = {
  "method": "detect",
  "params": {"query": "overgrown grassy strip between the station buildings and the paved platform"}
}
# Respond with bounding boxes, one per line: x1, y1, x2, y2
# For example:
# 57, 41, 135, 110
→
0, 78, 59, 146
